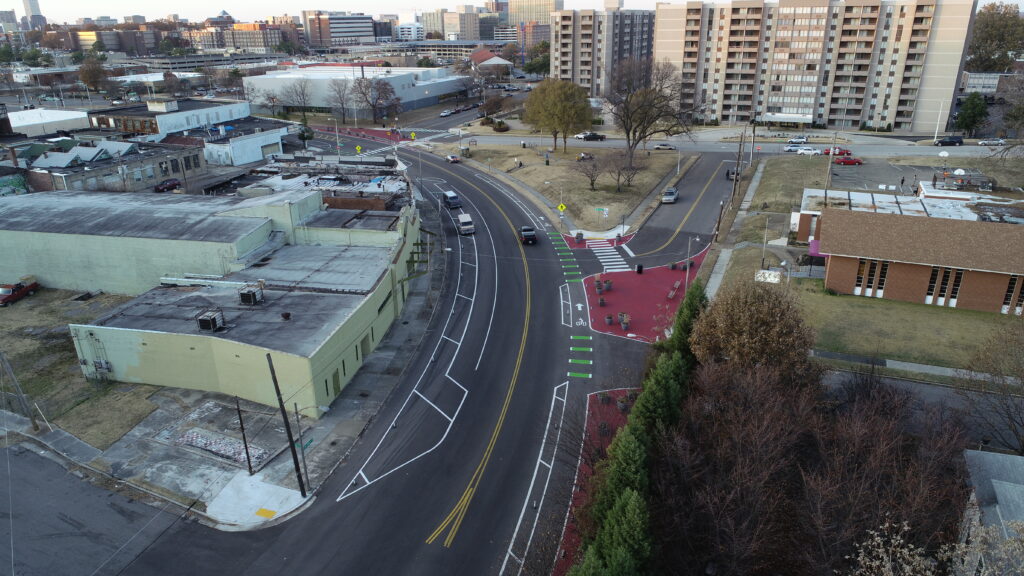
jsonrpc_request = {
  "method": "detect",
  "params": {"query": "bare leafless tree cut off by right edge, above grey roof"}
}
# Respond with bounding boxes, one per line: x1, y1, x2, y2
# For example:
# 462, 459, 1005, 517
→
958, 318, 1024, 455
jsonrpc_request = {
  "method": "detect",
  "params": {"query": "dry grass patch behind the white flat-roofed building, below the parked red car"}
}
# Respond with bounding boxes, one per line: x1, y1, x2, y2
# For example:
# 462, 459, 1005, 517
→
751, 155, 828, 212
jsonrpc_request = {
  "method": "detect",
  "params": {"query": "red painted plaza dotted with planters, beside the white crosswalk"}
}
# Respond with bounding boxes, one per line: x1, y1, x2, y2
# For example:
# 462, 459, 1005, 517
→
584, 250, 708, 342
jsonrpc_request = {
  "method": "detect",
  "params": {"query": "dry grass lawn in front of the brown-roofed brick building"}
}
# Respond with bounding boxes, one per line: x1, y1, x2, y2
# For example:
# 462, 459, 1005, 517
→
725, 242, 1012, 368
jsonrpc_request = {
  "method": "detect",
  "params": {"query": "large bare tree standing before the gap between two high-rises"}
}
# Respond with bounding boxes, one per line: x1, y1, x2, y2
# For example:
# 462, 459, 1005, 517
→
607, 58, 691, 166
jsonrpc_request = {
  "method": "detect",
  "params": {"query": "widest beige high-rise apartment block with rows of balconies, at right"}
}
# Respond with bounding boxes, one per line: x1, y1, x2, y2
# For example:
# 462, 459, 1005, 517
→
654, 0, 977, 132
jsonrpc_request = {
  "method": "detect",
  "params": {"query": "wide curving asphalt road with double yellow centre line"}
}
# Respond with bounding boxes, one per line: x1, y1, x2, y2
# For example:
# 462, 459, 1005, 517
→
112, 136, 645, 575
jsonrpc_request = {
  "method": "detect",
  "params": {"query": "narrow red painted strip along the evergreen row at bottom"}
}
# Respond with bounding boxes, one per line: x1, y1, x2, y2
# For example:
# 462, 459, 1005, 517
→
551, 388, 636, 576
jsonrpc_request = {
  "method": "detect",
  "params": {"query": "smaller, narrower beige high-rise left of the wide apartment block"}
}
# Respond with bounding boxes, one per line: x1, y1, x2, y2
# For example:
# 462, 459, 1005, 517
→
551, 9, 654, 97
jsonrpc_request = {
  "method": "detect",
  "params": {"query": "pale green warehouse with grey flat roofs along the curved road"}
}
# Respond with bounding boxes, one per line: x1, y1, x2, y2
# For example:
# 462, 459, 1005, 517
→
0, 183, 419, 416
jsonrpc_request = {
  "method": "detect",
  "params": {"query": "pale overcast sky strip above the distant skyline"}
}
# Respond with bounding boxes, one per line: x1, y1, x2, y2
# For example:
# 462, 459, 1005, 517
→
9, 0, 1022, 23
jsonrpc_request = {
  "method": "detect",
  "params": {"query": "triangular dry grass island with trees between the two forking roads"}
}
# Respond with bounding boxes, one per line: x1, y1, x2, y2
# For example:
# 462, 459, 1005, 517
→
436, 139, 687, 231
